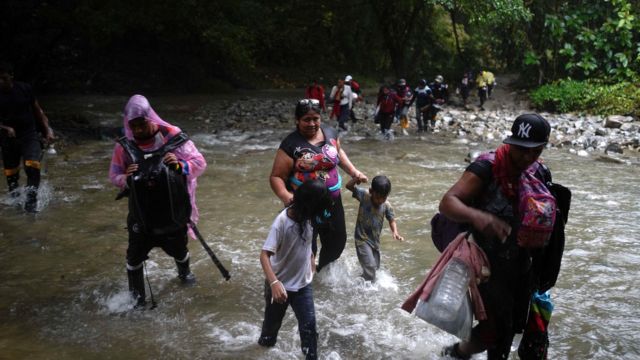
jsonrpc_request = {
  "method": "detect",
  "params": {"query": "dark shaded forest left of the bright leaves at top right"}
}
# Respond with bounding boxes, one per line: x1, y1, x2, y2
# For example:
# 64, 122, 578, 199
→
0, 0, 530, 93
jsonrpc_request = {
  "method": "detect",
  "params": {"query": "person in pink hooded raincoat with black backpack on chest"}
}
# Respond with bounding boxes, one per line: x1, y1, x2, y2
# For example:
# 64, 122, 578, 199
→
109, 95, 207, 306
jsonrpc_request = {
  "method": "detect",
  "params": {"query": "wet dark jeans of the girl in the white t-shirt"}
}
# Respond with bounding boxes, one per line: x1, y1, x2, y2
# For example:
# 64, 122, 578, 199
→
258, 281, 318, 359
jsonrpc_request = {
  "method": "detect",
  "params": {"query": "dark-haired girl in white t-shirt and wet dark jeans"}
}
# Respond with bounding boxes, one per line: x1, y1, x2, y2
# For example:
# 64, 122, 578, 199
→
258, 180, 331, 359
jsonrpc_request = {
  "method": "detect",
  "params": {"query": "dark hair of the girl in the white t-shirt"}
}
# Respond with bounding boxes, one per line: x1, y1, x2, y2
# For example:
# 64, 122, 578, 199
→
291, 180, 332, 236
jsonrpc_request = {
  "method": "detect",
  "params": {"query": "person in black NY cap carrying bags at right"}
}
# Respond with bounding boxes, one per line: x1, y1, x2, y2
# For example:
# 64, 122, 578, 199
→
440, 114, 561, 360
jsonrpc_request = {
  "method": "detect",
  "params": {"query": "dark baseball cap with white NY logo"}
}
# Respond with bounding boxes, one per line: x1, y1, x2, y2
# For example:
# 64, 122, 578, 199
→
502, 114, 551, 148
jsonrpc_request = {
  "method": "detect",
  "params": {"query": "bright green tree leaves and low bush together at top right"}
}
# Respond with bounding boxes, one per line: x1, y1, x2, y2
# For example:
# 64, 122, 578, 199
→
524, 0, 640, 115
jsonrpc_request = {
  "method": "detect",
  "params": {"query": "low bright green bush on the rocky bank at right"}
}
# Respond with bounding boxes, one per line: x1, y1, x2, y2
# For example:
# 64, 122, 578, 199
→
529, 79, 640, 116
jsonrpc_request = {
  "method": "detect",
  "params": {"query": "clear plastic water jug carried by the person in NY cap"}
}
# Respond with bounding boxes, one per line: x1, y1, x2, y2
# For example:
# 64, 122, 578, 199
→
424, 258, 470, 325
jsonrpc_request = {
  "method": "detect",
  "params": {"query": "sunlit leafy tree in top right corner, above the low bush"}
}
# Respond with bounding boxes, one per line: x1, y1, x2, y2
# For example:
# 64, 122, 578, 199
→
525, 0, 640, 81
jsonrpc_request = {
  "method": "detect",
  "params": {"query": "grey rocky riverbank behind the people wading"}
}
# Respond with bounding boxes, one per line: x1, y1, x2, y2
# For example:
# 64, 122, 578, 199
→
193, 97, 640, 164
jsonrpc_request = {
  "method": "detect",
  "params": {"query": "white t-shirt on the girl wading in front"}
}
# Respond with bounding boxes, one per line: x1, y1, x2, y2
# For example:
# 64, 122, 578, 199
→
262, 209, 313, 291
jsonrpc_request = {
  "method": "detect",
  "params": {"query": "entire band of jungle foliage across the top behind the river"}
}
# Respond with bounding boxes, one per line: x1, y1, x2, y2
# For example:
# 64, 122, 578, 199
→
0, 0, 640, 114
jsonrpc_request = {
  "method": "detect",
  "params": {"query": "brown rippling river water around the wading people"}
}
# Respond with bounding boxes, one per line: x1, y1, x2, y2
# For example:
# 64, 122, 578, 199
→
0, 97, 640, 360
